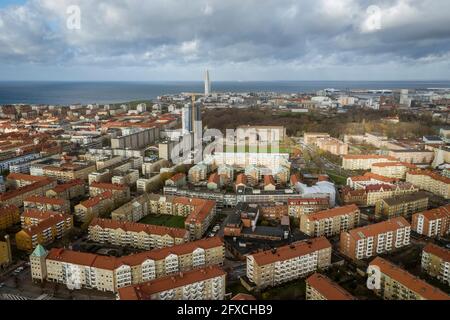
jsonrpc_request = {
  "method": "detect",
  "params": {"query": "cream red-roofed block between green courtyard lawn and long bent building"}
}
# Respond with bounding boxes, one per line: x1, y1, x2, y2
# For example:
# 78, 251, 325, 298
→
89, 218, 189, 250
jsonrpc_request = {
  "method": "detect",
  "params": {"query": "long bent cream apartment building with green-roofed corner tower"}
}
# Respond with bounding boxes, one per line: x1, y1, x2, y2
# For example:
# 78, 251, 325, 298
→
30, 237, 225, 292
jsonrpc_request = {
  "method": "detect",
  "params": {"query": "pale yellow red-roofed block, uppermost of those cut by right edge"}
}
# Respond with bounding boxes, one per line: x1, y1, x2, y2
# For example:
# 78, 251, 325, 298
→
406, 170, 450, 199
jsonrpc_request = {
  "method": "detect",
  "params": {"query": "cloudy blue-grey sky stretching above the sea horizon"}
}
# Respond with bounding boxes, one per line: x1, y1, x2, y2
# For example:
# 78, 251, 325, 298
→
0, 0, 450, 81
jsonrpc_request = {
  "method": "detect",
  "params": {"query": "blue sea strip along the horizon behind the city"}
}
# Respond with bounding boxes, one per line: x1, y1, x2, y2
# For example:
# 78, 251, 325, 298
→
0, 81, 450, 105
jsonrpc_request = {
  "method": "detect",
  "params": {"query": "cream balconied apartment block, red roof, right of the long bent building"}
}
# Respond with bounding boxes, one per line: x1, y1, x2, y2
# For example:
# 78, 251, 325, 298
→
247, 237, 331, 289
